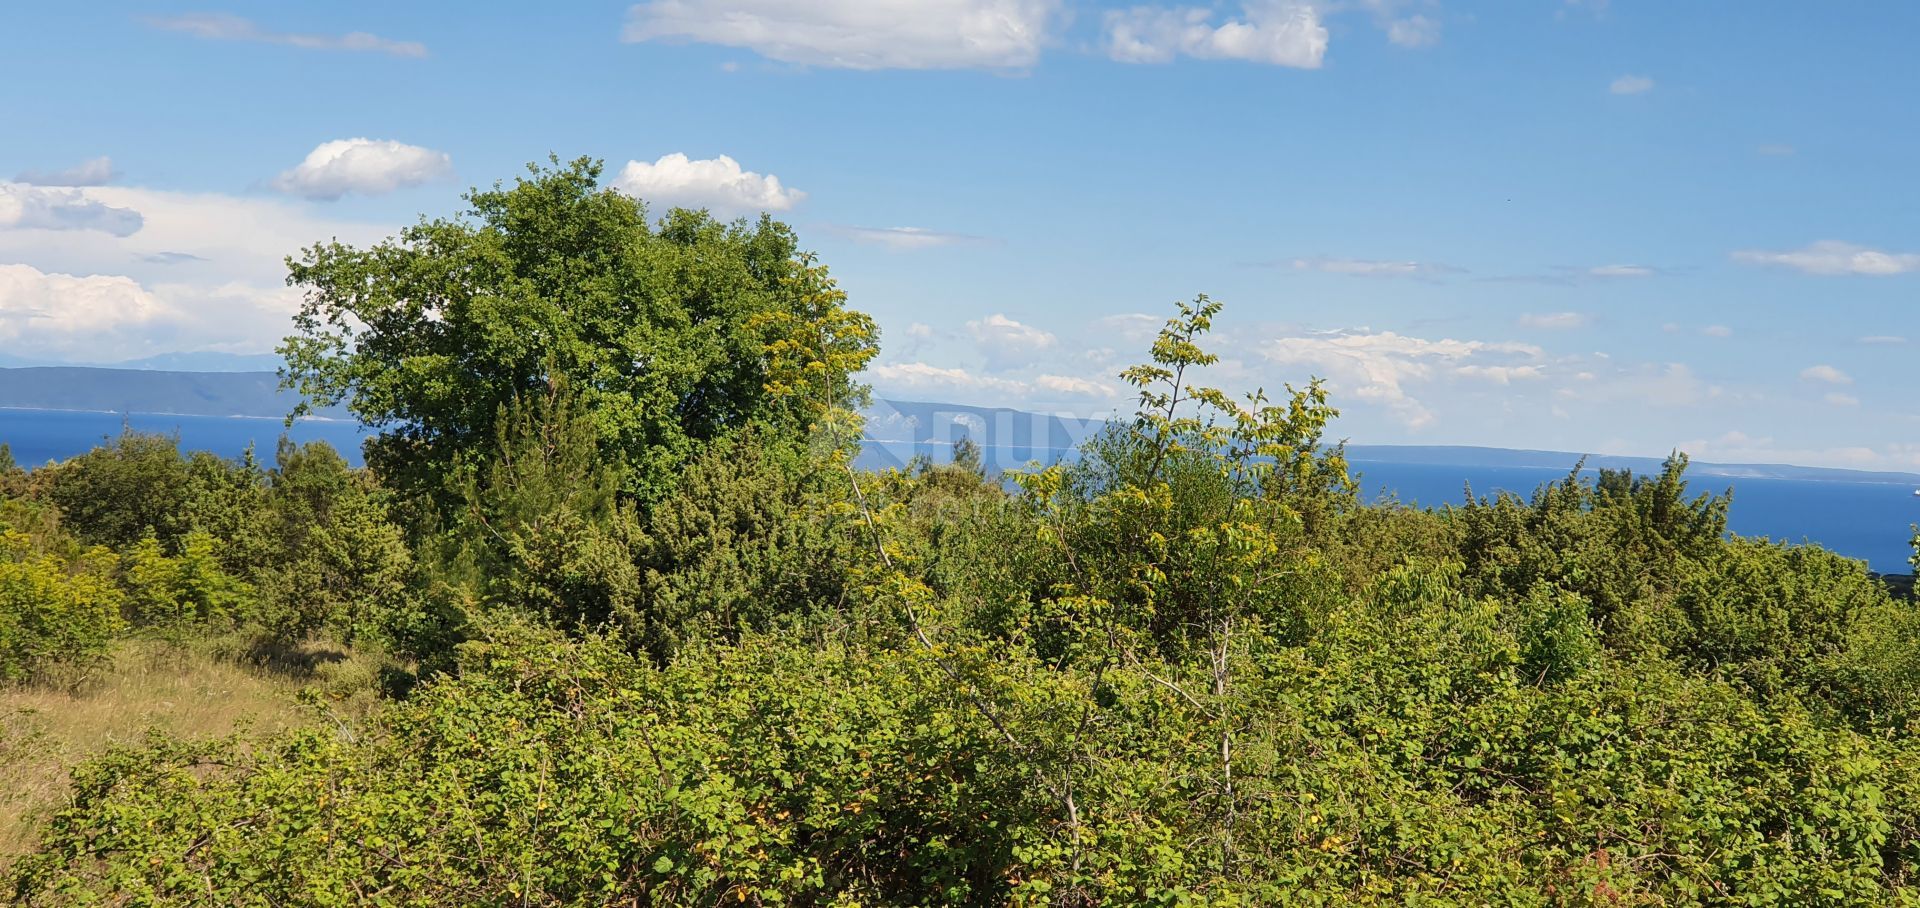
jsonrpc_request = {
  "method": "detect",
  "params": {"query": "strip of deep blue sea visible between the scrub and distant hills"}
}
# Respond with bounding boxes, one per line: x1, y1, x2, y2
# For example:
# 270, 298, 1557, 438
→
0, 409, 1920, 574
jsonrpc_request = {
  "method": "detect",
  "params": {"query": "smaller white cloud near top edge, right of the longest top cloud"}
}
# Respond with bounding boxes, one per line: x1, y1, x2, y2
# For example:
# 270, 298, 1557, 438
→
1106, 0, 1327, 69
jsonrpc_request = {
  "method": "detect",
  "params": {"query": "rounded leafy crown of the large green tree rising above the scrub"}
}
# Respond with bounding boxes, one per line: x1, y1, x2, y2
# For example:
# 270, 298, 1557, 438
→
282, 159, 876, 503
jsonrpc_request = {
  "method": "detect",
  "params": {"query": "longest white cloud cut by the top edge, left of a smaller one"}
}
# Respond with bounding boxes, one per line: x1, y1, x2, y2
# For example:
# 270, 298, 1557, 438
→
622, 0, 1060, 69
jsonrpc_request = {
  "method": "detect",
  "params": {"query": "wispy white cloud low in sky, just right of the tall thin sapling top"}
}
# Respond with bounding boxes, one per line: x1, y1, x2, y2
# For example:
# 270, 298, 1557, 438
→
1260, 332, 1542, 430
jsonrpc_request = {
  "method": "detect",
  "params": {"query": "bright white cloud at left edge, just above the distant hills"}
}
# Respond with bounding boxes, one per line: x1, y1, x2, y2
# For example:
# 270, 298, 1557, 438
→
0, 265, 177, 359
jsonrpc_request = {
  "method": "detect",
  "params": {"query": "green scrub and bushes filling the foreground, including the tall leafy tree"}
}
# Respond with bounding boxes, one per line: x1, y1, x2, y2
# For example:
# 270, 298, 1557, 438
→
0, 161, 1920, 906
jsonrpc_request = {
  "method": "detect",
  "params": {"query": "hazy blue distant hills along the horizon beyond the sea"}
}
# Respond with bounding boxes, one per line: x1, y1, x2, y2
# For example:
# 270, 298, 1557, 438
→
0, 367, 1920, 486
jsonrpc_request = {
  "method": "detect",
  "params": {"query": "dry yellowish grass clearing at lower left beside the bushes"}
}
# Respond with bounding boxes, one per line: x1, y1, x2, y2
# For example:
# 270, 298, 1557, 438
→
0, 639, 378, 870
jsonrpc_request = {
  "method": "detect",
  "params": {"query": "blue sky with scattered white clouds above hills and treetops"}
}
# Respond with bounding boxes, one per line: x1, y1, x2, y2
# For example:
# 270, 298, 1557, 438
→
0, 0, 1920, 470
